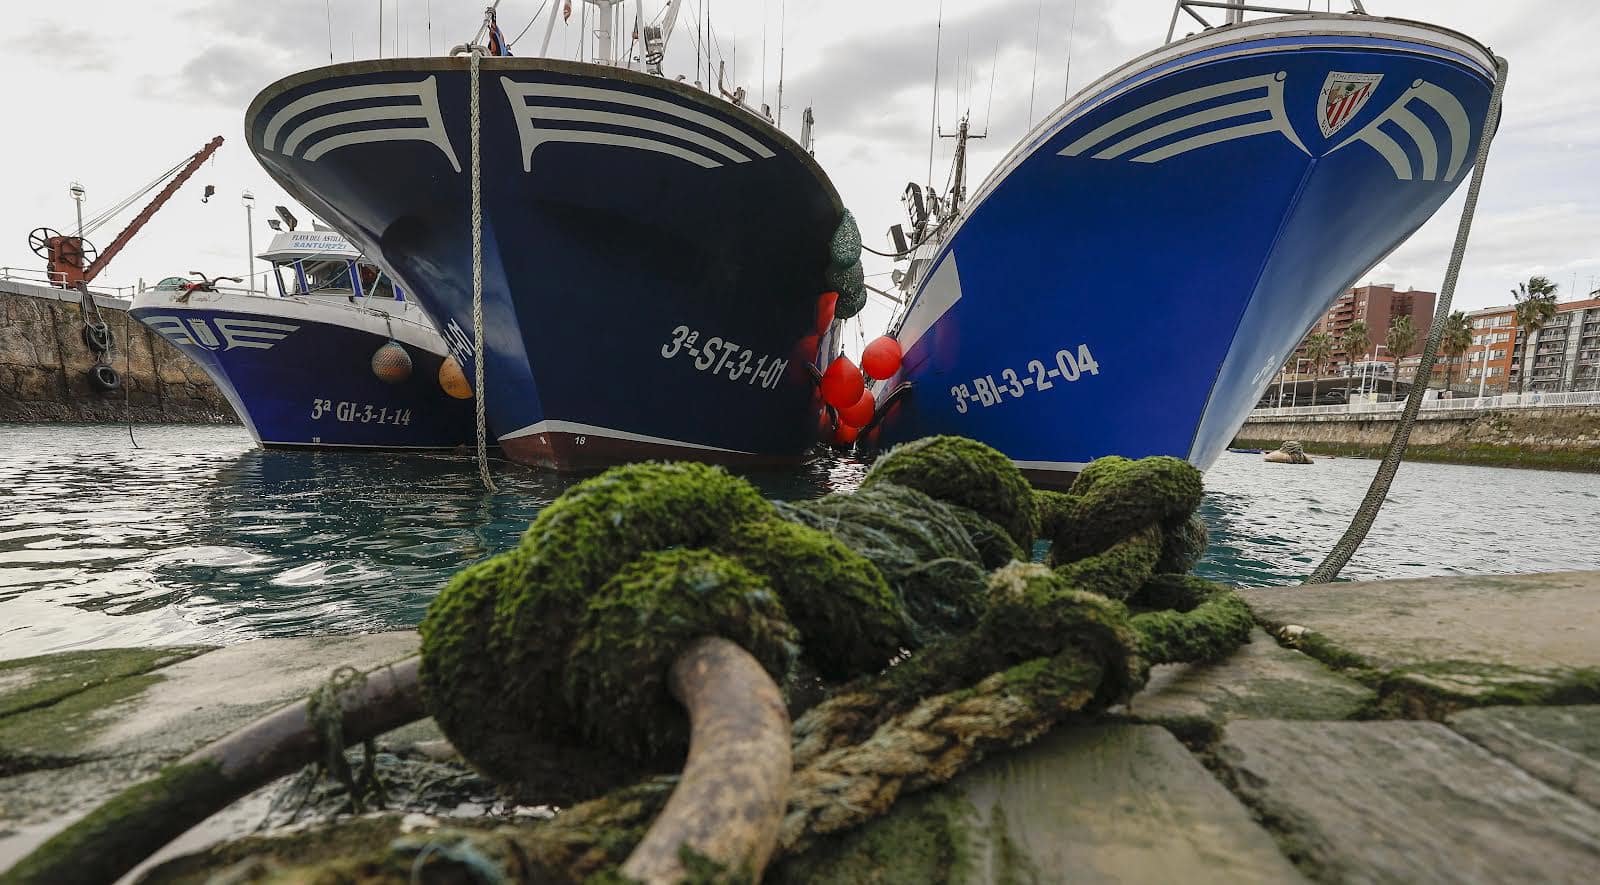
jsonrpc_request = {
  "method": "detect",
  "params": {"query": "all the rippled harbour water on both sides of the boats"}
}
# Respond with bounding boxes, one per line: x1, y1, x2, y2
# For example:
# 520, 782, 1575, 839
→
0, 424, 1600, 658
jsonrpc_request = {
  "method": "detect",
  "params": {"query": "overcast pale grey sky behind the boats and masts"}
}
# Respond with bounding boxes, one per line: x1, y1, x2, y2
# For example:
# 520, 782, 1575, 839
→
0, 0, 1600, 336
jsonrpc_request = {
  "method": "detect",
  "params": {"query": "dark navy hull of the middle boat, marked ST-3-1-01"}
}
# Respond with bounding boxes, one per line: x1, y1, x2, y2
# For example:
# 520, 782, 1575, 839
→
245, 58, 842, 469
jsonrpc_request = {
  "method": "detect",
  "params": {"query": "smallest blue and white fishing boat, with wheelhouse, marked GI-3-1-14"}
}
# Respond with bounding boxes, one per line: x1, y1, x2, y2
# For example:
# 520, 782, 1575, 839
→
131, 230, 474, 450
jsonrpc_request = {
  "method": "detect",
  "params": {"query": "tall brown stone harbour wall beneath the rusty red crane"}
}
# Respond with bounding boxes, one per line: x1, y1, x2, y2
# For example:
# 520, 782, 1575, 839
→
0, 280, 238, 424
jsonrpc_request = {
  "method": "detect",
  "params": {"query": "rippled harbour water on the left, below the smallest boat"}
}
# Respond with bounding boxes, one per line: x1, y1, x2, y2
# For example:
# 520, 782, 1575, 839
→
0, 426, 866, 658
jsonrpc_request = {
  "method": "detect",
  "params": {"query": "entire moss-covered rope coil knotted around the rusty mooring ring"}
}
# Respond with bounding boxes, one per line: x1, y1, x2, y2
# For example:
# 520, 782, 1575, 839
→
15, 437, 1251, 882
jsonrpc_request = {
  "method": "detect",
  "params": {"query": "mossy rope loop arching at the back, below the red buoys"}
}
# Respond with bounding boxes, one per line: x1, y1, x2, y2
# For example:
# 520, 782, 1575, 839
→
861, 437, 1038, 549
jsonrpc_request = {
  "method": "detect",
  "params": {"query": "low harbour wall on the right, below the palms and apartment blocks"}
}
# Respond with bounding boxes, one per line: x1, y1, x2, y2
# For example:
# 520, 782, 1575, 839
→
1234, 405, 1600, 472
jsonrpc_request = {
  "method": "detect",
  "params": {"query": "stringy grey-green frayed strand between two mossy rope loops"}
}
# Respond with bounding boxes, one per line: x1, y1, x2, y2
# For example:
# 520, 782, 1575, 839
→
779, 482, 987, 648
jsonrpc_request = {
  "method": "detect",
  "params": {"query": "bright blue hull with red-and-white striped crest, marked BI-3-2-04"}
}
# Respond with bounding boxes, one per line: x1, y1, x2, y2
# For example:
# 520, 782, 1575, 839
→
867, 14, 1496, 485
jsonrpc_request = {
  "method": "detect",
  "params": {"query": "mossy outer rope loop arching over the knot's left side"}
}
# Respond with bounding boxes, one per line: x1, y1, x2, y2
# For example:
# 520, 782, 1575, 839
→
490, 463, 776, 743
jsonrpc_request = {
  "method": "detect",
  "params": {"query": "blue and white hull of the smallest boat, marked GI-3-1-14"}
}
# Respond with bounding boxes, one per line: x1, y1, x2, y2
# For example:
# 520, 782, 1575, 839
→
131, 288, 474, 450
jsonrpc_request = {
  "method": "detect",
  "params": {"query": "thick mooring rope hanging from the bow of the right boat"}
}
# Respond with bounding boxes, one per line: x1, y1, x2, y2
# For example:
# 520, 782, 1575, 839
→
1306, 56, 1509, 584
